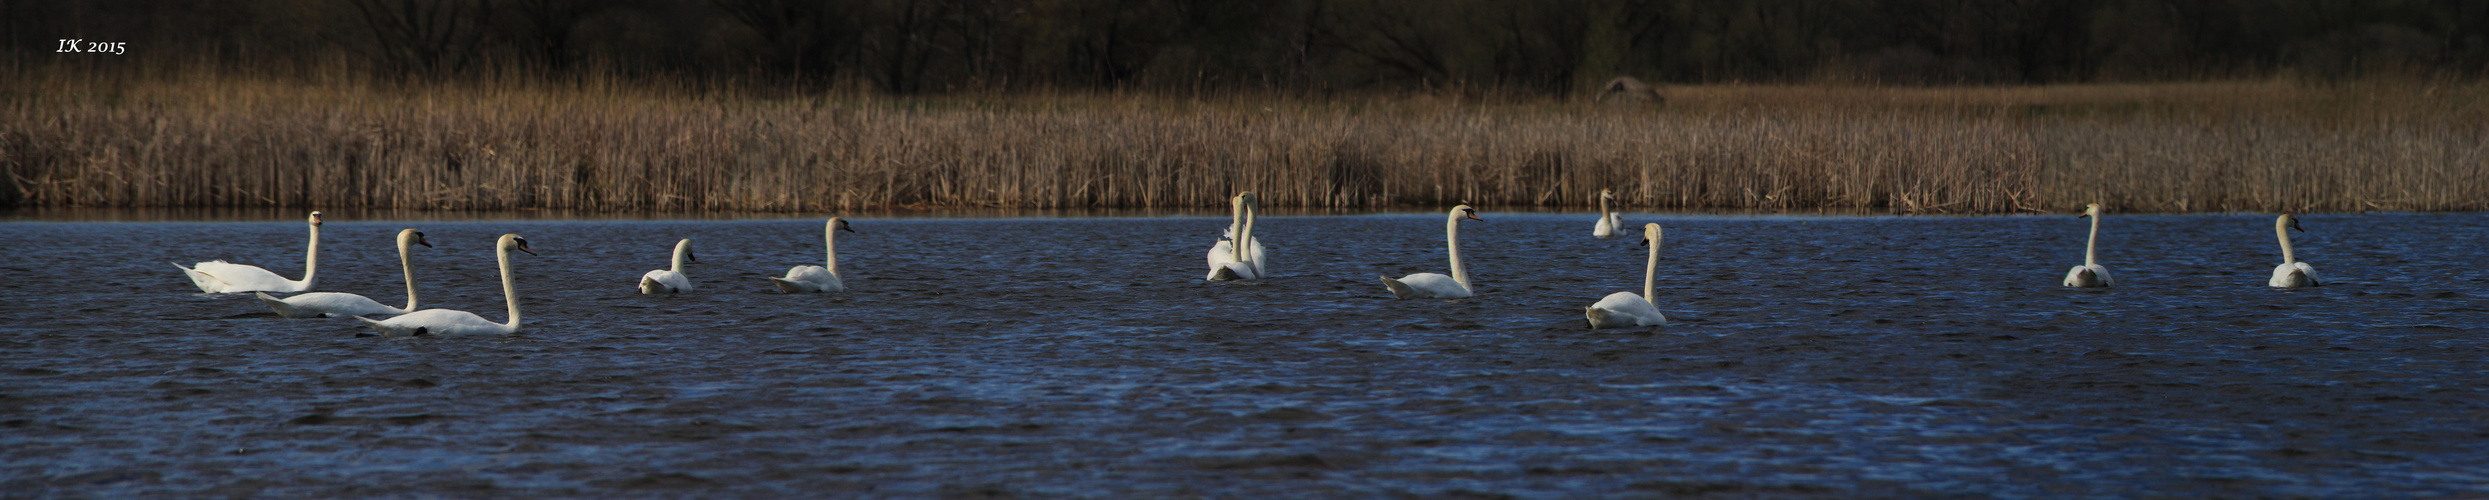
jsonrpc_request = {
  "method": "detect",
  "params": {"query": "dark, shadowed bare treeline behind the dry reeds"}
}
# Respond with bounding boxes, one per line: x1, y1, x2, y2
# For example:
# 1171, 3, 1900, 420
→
14, 0, 2489, 95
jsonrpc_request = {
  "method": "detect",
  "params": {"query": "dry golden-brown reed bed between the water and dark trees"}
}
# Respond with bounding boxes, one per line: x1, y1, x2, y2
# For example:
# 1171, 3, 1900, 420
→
0, 75, 2489, 214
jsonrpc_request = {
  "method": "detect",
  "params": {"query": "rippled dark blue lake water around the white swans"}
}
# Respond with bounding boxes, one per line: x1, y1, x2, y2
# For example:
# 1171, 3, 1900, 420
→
0, 211, 2489, 498
